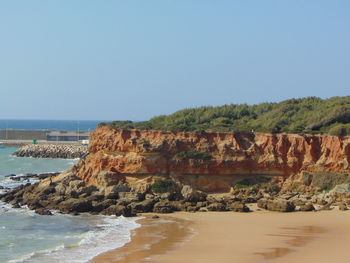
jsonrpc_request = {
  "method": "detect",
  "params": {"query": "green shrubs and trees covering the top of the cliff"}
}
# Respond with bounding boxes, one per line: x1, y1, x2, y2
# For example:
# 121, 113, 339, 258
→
100, 96, 350, 136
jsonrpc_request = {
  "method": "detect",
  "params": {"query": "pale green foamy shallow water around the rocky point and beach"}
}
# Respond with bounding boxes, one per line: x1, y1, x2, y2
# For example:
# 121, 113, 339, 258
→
0, 147, 139, 263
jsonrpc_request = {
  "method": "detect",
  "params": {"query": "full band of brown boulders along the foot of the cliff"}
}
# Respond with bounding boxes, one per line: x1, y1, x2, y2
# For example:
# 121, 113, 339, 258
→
0, 170, 350, 216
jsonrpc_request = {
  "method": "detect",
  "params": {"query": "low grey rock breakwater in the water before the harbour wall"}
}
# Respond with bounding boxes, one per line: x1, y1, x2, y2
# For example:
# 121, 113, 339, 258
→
13, 144, 88, 159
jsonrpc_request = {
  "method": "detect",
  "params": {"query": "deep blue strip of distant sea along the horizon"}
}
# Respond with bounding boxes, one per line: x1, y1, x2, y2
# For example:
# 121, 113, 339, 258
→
0, 120, 106, 131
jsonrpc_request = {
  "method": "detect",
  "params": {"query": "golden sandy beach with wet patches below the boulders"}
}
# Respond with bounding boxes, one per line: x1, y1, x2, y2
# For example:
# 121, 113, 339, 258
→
91, 211, 350, 263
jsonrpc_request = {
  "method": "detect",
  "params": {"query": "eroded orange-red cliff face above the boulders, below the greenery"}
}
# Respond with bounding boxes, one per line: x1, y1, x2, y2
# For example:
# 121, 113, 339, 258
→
74, 127, 350, 192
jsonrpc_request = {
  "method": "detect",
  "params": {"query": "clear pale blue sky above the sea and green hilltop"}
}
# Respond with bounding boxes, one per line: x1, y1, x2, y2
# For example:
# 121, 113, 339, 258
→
0, 0, 350, 120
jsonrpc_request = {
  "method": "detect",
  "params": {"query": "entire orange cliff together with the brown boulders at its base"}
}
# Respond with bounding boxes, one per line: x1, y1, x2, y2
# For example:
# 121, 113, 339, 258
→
0, 127, 350, 216
